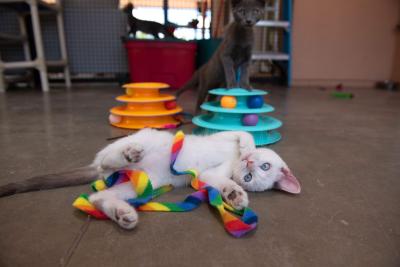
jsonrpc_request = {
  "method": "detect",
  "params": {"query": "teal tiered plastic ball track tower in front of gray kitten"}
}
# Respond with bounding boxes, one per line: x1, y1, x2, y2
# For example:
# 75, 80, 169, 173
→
193, 88, 282, 146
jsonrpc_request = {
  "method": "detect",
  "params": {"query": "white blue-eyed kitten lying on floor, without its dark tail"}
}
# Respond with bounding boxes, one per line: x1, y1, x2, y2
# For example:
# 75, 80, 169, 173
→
89, 129, 300, 229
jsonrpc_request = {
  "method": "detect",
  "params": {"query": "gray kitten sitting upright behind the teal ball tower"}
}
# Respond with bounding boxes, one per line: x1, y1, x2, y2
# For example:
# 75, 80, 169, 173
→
177, 0, 265, 113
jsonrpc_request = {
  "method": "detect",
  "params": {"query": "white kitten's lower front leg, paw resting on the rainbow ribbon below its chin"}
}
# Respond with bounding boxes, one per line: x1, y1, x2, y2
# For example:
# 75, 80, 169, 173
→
199, 161, 249, 210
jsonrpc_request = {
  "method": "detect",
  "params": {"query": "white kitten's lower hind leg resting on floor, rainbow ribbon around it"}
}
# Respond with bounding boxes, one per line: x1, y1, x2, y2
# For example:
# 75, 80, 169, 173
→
89, 182, 139, 229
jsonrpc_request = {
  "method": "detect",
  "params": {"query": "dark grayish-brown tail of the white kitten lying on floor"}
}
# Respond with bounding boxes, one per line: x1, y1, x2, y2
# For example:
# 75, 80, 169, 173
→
0, 166, 99, 197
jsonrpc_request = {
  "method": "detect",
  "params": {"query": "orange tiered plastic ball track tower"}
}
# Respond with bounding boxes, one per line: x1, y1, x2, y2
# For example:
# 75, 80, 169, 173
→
109, 83, 182, 129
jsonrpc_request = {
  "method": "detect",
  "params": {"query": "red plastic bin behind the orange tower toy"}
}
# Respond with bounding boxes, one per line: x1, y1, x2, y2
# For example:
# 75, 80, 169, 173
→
125, 40, 197, 88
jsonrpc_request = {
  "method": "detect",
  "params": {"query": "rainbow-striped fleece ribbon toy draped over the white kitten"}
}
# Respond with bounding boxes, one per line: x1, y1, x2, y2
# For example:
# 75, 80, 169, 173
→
73, 131, 258, 237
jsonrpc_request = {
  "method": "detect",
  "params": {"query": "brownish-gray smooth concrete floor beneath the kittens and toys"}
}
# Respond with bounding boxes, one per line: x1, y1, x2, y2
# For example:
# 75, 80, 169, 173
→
0, 86, 400, 267
